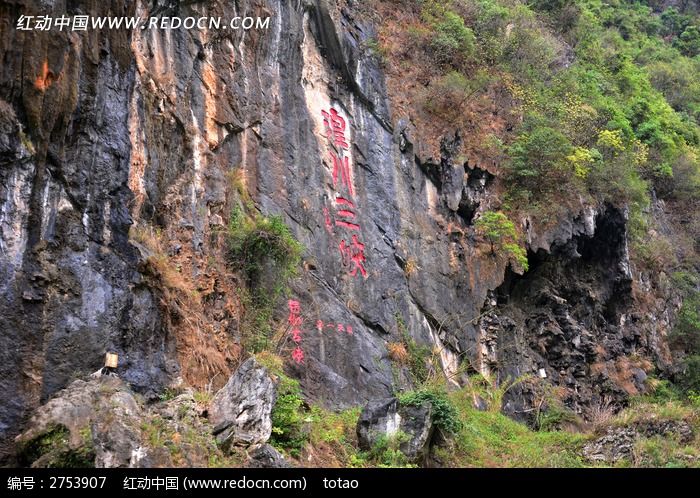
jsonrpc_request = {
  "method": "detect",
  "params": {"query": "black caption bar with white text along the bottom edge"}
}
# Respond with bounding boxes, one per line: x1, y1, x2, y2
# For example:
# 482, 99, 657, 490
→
0, 468, 700, 498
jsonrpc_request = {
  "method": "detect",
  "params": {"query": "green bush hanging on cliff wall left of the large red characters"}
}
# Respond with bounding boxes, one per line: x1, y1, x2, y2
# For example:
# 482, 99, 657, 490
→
227, 207, 304, 352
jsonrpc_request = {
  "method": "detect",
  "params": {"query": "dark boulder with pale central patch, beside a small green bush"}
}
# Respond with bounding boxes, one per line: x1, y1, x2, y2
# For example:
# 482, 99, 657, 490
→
357, 398, 434, 462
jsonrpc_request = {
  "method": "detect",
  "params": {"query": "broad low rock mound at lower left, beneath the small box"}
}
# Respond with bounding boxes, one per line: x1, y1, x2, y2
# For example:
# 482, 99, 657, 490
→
15, 376, 238, 468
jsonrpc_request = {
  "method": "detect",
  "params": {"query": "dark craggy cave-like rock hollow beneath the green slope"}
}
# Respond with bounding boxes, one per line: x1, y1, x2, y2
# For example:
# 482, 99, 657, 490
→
479, 206, 669, 421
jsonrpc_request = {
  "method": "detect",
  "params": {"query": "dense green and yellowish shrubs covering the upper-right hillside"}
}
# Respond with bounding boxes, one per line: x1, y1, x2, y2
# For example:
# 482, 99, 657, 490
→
388, 0, 700, 263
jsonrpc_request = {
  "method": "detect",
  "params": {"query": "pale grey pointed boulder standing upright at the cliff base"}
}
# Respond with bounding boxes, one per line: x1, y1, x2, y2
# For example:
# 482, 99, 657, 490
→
209, 358, 276, 449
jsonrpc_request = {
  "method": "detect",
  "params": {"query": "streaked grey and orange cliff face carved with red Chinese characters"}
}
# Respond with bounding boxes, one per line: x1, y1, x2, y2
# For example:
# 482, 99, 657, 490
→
0, 0, 674, 460
